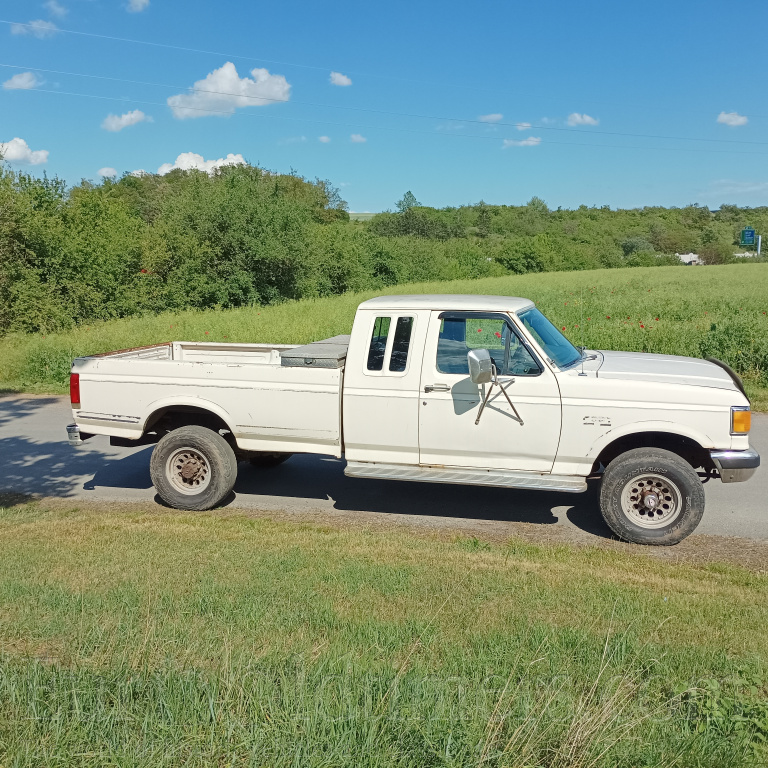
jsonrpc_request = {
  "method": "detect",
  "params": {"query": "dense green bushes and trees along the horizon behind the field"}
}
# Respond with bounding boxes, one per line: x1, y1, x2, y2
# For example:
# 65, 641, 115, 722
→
0, 166, 768, 334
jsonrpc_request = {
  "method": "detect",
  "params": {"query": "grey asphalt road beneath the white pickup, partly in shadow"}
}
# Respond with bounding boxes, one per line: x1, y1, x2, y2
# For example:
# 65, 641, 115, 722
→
0, 395, 768, 540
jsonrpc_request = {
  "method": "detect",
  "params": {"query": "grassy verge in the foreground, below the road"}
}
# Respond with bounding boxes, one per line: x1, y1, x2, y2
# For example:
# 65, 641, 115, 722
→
0, 503, 768, 768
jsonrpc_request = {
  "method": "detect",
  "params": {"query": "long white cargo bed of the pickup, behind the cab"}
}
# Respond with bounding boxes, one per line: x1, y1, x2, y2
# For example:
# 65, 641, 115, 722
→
73, 336, 349, 456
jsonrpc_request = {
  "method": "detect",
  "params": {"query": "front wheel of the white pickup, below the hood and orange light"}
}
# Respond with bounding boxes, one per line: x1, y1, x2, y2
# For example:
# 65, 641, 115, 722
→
600, 448, 704, 546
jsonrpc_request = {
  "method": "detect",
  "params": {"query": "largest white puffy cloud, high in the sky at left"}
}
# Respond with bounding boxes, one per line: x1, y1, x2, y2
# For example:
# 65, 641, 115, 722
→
168, 61, 291, 120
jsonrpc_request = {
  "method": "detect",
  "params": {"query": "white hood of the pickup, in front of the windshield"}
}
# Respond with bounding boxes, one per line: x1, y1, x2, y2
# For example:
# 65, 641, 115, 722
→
597, 351, 739, 392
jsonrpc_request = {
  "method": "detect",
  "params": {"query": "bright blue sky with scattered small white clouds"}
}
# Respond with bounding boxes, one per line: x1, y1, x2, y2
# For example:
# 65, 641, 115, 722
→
0, 0, 768, 211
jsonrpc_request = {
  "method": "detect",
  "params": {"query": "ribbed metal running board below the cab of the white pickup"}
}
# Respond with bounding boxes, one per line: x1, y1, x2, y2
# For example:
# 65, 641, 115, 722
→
344, 461, 587, 493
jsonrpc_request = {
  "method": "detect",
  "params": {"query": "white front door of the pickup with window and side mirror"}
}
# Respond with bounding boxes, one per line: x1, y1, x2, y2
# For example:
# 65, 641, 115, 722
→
419, 312, 561, 473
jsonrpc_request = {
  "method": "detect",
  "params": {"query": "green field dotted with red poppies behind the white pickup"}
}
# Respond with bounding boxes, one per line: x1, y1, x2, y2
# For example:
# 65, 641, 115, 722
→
0, 264, 768, 410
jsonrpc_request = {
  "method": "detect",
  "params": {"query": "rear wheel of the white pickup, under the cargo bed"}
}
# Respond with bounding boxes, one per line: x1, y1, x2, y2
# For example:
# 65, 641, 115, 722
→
149, 426, 237, 511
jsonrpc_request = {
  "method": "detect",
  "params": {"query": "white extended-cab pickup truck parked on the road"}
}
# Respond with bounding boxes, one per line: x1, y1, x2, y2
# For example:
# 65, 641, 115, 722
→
68, 295, 760, 544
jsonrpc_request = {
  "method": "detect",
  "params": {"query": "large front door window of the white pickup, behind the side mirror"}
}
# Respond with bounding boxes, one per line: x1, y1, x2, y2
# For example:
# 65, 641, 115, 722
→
437, 316, 541, 376
